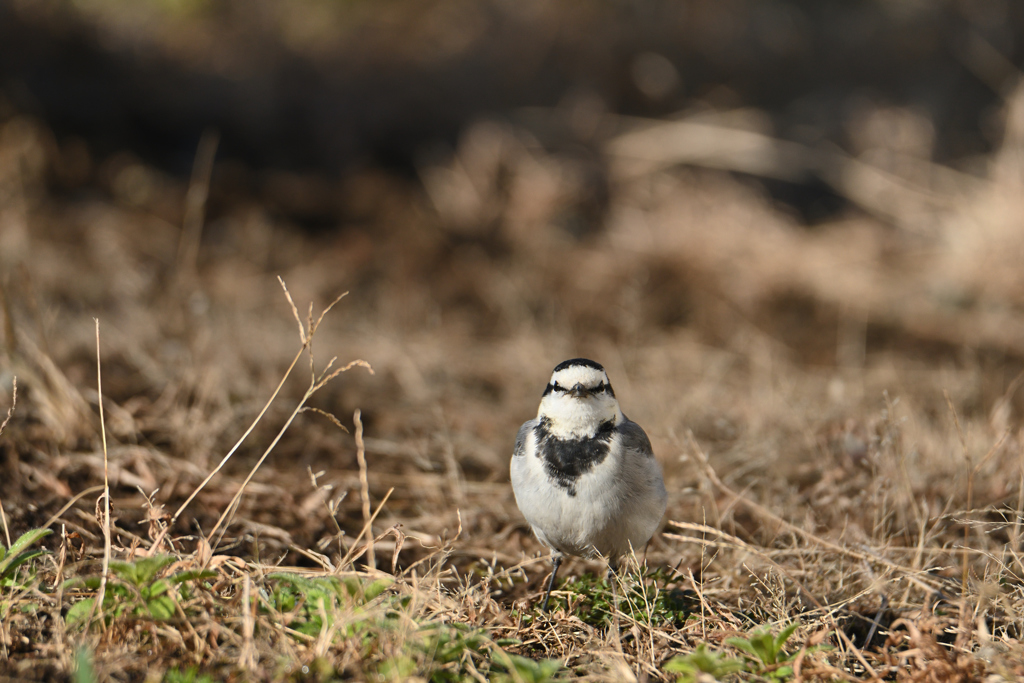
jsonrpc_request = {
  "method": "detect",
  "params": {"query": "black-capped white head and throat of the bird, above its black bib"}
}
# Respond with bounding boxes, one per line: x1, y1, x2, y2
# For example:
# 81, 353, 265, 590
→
537, 364, 623, 438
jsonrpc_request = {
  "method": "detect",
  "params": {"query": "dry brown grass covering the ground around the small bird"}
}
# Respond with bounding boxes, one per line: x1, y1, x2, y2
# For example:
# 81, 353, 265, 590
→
0, 78, 1024, 681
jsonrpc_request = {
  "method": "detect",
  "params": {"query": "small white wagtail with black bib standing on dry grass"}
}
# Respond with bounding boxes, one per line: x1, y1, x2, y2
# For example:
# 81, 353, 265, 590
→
511, 358, 668, 611
